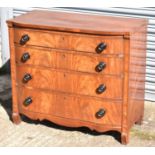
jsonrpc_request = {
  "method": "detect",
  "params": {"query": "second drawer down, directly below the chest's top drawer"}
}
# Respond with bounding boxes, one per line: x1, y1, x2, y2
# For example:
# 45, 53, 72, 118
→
15, 46, 123, 75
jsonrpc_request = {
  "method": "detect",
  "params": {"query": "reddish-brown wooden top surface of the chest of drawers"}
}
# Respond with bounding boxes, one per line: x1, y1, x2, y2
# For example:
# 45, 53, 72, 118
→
7, 10, 147, 35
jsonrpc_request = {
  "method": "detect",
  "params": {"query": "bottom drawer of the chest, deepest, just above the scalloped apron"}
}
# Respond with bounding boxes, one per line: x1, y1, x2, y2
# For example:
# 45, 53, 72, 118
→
18, 87, 122, 125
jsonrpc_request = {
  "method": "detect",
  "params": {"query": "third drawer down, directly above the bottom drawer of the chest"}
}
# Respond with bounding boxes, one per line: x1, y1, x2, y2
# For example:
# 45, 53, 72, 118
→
17, 66, 122, 99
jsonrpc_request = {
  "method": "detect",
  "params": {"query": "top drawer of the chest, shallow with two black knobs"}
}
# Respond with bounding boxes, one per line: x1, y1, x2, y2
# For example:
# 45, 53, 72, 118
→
14, 28, 123, 54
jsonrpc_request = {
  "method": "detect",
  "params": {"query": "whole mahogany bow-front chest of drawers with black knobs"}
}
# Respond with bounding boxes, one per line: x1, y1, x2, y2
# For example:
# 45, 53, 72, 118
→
7, 11, 147, 144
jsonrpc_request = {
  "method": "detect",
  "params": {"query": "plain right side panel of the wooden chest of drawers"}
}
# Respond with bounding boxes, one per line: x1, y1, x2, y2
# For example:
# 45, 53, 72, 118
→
128, 25, 147, 127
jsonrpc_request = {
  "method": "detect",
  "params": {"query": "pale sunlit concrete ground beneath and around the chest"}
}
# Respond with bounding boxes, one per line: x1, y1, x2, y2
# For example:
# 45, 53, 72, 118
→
0, 75, 155, 147
